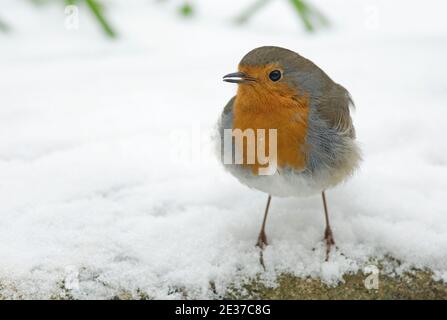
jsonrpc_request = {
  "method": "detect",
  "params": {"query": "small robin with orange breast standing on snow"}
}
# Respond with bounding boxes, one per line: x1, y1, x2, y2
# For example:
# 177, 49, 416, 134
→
218, 46, 361, 262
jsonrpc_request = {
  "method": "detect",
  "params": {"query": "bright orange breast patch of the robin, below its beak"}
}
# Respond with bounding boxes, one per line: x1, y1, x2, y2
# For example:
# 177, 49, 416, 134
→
233, 84, 309, 174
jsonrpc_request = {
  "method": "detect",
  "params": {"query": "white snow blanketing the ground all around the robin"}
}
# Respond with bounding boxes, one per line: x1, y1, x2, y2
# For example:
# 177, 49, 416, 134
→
0, 0, 447, 298
